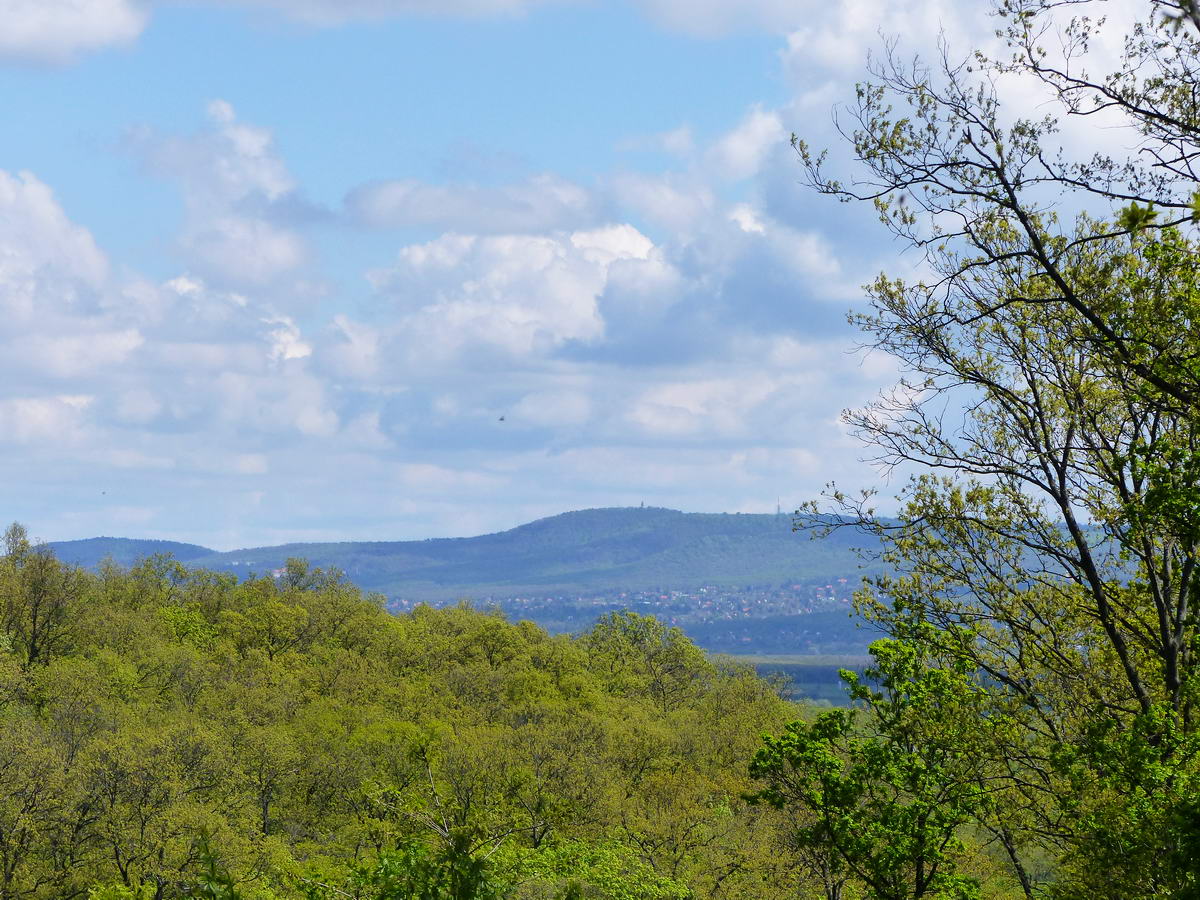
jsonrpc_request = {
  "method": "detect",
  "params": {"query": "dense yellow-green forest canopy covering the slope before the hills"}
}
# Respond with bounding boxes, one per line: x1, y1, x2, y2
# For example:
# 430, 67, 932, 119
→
0, 526, 809, 900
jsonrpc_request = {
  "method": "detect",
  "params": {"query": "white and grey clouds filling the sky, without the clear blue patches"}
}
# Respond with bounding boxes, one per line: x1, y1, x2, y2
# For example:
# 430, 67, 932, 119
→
0, 0, 1041, 547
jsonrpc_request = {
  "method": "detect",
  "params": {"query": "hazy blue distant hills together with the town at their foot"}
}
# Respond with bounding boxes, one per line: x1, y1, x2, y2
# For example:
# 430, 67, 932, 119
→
50, 508, 875, 654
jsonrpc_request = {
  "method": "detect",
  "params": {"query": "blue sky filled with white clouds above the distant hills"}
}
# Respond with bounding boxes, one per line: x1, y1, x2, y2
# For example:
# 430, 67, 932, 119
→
0, 0, 1022, 550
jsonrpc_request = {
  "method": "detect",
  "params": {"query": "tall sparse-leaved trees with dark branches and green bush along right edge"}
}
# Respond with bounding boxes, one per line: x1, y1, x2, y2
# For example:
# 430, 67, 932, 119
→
755, 0, 1200, 899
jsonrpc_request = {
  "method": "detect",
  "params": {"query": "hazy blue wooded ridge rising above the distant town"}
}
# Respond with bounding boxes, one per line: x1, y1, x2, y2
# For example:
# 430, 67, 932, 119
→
50, 508, 865, 601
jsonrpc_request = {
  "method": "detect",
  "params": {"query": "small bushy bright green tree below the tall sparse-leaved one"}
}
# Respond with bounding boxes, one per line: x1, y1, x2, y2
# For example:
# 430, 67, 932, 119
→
750, 641, 990, 900
